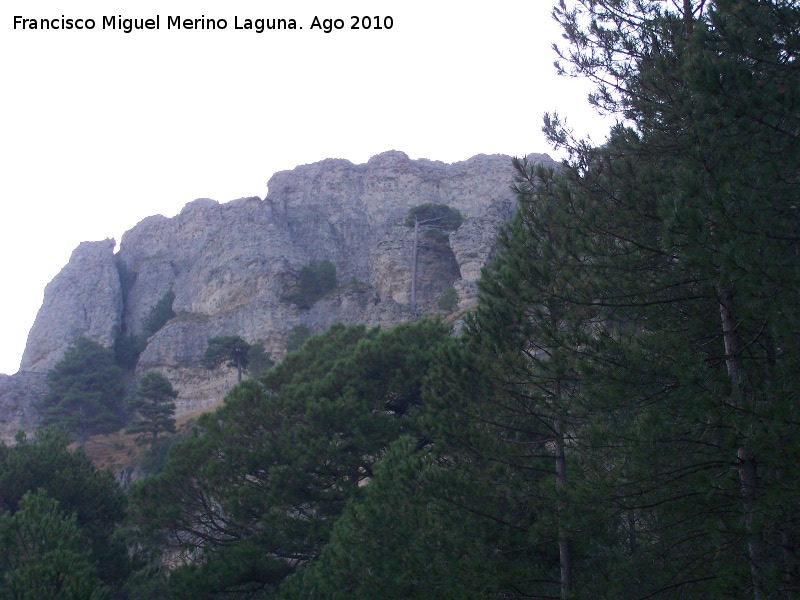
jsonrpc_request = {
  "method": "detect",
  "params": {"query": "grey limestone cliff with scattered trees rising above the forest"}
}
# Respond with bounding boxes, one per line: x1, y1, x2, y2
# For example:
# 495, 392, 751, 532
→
0, 151, 552, 438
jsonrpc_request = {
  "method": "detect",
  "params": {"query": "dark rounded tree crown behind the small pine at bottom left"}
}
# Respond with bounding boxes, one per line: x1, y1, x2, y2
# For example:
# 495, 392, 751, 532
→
0, 430, 128, 597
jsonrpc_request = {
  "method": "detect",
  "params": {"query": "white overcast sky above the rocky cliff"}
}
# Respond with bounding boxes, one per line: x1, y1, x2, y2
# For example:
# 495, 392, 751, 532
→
0, 0, 608, 373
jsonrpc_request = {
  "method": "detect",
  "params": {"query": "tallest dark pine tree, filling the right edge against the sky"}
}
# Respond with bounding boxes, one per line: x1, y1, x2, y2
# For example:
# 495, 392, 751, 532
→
504, 1, 800, 598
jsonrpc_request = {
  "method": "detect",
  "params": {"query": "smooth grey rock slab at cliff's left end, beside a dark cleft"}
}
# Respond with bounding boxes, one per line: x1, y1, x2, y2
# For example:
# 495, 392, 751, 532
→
20, 239, 122, 373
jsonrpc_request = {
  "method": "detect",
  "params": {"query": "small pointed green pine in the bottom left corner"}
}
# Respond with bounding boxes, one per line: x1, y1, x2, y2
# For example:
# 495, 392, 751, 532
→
0, 490, 106, 600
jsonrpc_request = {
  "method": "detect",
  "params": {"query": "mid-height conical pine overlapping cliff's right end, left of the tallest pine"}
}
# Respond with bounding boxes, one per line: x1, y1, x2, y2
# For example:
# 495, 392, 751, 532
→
424, 161, 620, 597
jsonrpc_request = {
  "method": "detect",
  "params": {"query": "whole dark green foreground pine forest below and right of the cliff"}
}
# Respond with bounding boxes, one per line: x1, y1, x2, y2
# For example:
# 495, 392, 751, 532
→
0, 0, 800, 600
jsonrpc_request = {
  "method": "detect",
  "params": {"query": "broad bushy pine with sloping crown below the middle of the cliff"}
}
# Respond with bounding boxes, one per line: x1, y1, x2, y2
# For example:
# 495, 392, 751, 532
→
127, 322, 450, 595
